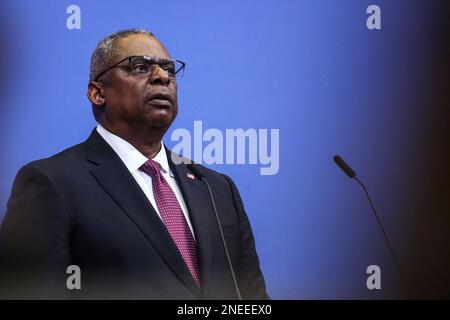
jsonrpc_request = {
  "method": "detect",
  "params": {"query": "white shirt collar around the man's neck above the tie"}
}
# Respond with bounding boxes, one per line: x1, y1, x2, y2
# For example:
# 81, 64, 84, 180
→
96, 124, 173, 177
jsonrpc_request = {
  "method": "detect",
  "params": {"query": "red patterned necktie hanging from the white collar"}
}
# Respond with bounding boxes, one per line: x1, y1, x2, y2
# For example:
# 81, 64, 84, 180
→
140, 160, 200, 287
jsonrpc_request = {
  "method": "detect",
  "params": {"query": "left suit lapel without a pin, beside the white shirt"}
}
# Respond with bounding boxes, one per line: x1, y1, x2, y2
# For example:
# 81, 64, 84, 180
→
85, 129, 200, 296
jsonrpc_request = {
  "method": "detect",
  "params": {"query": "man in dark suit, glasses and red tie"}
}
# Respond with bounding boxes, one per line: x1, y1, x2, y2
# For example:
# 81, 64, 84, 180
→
0, 30, 267, 299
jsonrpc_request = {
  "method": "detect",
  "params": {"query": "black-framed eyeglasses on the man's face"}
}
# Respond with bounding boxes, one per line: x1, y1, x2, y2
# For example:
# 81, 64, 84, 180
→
94, 56, 186, 81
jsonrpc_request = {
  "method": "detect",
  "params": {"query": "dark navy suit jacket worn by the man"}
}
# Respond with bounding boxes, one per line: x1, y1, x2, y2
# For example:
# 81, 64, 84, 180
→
0, 130, 267, 299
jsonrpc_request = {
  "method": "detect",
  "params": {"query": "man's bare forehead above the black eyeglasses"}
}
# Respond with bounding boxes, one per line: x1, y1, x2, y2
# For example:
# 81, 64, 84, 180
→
116, 34, 170, 58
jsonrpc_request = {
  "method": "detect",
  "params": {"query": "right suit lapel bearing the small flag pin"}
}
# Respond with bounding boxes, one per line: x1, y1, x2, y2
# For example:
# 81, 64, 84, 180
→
166, 148, 216, 292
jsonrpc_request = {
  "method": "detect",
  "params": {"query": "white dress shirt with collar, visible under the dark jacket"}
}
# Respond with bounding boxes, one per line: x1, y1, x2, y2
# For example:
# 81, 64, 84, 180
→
97, 124, 195, 237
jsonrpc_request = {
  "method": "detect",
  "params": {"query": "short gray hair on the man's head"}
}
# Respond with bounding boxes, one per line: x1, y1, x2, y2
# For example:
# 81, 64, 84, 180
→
89, 29, 154, 81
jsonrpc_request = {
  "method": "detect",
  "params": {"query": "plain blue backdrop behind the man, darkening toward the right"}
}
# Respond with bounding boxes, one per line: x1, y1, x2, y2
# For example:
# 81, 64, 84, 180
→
0, 0, 450, 299
